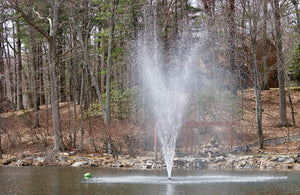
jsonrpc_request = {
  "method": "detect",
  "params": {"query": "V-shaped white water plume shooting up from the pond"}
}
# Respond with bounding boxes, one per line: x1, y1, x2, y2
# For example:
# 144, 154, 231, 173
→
136, 7, 196, 179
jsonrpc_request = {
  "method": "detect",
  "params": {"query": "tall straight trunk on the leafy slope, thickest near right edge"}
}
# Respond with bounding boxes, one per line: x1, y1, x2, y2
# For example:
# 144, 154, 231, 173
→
273, 0, 287, 126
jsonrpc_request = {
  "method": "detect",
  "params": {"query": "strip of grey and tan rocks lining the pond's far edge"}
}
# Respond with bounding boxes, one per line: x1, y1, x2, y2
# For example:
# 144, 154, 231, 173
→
0, 152, 300, 171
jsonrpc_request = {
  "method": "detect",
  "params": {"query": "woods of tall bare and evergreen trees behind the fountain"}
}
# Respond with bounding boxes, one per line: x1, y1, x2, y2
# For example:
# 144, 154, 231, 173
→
0, 0, 300, 155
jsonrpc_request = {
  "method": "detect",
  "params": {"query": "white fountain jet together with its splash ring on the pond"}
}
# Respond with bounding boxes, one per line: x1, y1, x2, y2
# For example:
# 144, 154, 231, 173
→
78, 3, 288, 194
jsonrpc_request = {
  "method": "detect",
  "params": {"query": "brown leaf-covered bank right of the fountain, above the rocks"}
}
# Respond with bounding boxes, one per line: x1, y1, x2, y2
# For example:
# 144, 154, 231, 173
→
239, 89, 300, 154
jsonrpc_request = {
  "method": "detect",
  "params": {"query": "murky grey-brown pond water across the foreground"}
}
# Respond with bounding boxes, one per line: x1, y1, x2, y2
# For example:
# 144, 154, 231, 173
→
0, 166, 300, 195
